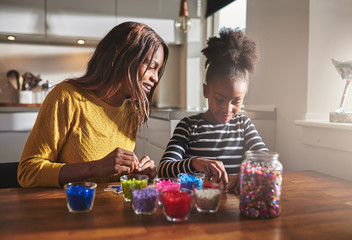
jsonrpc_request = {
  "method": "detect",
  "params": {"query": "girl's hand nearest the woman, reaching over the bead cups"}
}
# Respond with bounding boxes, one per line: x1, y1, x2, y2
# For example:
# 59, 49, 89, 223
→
191, 158, 229, 189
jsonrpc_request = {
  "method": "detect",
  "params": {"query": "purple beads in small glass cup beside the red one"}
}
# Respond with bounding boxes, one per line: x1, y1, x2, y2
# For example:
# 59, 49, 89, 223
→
132, 187, 159, 214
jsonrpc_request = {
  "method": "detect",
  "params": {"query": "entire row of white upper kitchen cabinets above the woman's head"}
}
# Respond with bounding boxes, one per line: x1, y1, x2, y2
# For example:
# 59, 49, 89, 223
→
0, 0, 201, 45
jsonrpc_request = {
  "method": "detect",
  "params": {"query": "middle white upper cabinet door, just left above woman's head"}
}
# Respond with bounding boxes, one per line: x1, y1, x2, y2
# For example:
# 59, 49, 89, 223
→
47, 0, 116, 39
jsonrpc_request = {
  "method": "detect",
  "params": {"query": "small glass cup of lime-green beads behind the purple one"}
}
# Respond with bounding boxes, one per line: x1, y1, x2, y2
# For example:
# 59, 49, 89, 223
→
120, 174, 148, 202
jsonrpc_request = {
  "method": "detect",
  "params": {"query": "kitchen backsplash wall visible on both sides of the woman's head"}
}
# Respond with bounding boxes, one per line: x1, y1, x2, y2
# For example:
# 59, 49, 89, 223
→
0, 43, 181, 104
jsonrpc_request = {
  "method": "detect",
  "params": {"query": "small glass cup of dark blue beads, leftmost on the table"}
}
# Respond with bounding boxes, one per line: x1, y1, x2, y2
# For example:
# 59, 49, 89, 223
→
64, 182, 97, 213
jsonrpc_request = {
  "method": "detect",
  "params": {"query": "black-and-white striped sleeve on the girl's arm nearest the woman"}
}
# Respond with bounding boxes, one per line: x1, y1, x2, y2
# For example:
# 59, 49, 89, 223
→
158, 118, 195, 177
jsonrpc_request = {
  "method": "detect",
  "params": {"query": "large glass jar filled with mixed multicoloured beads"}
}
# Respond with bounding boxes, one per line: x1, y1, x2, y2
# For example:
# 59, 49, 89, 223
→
240, 151, 283, 218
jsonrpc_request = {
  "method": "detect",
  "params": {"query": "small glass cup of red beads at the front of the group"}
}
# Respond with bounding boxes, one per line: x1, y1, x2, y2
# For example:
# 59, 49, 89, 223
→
161, 189, 193, 222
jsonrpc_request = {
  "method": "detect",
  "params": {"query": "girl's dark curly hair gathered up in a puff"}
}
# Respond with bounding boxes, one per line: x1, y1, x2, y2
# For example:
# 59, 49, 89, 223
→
202, 28, 258, 83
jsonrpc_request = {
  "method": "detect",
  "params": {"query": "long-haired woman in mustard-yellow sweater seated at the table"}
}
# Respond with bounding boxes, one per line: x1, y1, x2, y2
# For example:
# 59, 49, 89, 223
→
18, 22, 168, 187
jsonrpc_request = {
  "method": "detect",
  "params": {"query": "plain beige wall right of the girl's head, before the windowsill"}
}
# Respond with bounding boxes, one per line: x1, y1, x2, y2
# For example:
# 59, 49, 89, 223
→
245, 0, 309, 170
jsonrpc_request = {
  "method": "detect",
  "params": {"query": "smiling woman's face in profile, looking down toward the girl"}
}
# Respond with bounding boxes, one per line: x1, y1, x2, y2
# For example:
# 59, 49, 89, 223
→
139, 46, 164, 95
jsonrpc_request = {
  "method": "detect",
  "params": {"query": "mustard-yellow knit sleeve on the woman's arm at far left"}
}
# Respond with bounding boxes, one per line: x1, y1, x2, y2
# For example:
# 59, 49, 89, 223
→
17, 84, 75, 187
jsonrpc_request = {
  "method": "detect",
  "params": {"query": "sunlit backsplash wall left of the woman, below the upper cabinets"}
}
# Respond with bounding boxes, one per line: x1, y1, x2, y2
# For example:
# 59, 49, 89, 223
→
0, 43, 93, 102
